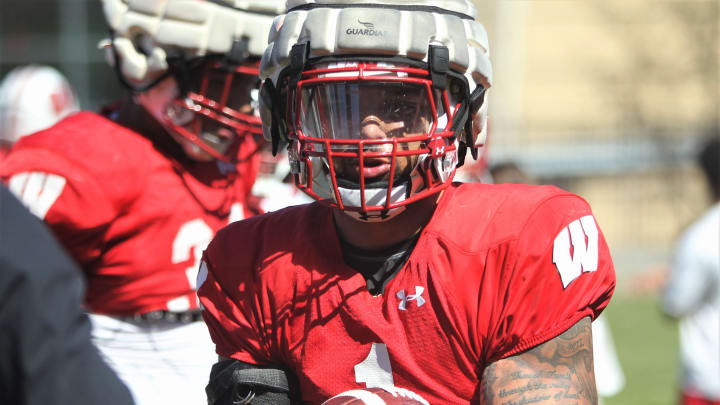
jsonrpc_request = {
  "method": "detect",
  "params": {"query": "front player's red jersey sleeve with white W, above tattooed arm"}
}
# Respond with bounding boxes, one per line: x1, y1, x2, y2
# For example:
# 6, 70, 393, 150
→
486, 194, 615, 362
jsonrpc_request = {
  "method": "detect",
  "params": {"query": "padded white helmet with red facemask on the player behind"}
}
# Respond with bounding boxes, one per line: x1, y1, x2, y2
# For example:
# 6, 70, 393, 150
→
101, 0, 284, 161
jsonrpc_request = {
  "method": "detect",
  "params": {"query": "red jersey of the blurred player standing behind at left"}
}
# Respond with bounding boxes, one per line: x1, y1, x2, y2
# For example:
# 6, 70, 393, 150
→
0, 112, 256, 316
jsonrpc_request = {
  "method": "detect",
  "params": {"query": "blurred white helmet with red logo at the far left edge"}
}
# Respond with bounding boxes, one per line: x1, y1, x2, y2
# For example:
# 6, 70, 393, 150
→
0, 65, 80, 161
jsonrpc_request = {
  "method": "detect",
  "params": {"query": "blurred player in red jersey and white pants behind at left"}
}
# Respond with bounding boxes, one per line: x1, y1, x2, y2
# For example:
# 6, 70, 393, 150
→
0, 0, 284, 405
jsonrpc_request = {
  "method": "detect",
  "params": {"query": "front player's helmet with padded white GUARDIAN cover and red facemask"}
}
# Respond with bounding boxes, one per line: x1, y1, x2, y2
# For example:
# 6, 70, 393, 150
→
260, 0, 492, 221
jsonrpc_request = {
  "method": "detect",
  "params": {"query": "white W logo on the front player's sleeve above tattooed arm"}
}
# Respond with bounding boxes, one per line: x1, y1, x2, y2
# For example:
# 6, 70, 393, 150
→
553, 215, 598, 288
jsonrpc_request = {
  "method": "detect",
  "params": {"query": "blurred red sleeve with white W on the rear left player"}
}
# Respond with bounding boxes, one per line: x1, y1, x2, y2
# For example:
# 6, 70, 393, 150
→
0, 148, 117, 266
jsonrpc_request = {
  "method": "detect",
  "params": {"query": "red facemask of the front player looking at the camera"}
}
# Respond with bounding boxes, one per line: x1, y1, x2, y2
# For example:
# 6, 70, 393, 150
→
287, 62, 459, 219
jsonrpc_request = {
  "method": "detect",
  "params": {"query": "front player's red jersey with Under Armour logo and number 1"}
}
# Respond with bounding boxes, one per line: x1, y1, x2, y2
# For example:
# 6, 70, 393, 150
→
198, 183, 615, 404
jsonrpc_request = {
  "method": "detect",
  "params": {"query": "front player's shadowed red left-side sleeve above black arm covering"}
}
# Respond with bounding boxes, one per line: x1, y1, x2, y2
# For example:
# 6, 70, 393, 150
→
197, 227, 270, 365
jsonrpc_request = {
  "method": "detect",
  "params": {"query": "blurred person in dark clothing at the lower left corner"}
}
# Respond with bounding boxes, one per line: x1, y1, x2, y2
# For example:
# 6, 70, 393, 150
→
0, 185, 132, 405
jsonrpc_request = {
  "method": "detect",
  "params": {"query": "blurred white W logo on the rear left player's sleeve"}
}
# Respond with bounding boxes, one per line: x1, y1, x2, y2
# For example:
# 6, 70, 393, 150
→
8, 172, 67, 219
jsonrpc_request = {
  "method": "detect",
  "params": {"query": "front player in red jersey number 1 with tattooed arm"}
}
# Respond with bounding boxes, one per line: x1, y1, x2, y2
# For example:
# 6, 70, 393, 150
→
198, 0, 615, 404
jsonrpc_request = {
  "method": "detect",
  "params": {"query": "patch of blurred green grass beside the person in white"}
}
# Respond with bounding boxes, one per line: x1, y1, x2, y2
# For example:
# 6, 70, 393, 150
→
604, 294, 677, 405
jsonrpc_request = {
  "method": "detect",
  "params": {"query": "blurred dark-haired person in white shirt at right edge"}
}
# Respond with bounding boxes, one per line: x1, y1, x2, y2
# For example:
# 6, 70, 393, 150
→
662, 132, 720, 405
